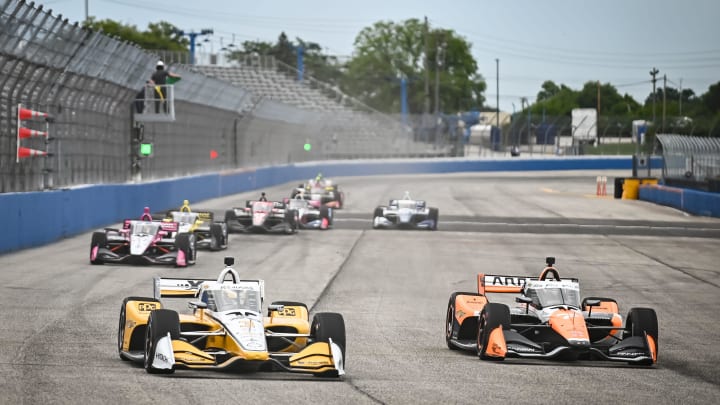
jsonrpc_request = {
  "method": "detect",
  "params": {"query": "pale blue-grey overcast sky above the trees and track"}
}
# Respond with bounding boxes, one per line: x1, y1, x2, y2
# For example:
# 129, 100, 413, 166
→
36, 0, 720, 112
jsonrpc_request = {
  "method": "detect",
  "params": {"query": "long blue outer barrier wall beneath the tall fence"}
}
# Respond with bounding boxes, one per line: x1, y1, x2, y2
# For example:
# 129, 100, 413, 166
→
0, 156, 687, 253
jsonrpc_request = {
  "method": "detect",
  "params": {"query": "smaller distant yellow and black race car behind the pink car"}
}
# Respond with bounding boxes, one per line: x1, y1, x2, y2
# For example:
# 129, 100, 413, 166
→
164, 200, 228, 250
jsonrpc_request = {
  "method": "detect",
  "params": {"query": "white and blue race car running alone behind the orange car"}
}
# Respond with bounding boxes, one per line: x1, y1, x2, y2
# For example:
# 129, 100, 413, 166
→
373, 192, 439, 231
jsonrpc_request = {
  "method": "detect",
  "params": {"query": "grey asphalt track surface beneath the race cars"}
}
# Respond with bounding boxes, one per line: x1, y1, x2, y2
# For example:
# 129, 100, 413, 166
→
0, 172, 720, 404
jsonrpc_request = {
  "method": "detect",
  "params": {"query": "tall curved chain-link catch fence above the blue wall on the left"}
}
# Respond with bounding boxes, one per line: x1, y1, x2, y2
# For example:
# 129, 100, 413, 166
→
0, 0, 438, 192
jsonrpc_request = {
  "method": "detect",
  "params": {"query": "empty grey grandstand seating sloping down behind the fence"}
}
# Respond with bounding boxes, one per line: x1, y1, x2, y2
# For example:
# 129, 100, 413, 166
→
191, 56, 446, 159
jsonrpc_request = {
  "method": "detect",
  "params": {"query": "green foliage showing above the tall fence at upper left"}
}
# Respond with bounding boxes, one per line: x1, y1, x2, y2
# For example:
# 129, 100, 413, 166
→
83, 17, 190, 51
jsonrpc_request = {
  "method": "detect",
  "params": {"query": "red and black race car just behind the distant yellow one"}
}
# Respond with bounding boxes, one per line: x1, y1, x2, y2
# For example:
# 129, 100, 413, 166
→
225, 193, 299, 234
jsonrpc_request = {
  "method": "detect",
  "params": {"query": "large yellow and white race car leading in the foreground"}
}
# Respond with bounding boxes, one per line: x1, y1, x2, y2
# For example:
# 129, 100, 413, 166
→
117, 257, 346, 377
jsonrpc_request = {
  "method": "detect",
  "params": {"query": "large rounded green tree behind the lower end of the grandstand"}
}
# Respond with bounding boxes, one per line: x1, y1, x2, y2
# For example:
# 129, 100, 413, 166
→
342, 19, 485, 113
